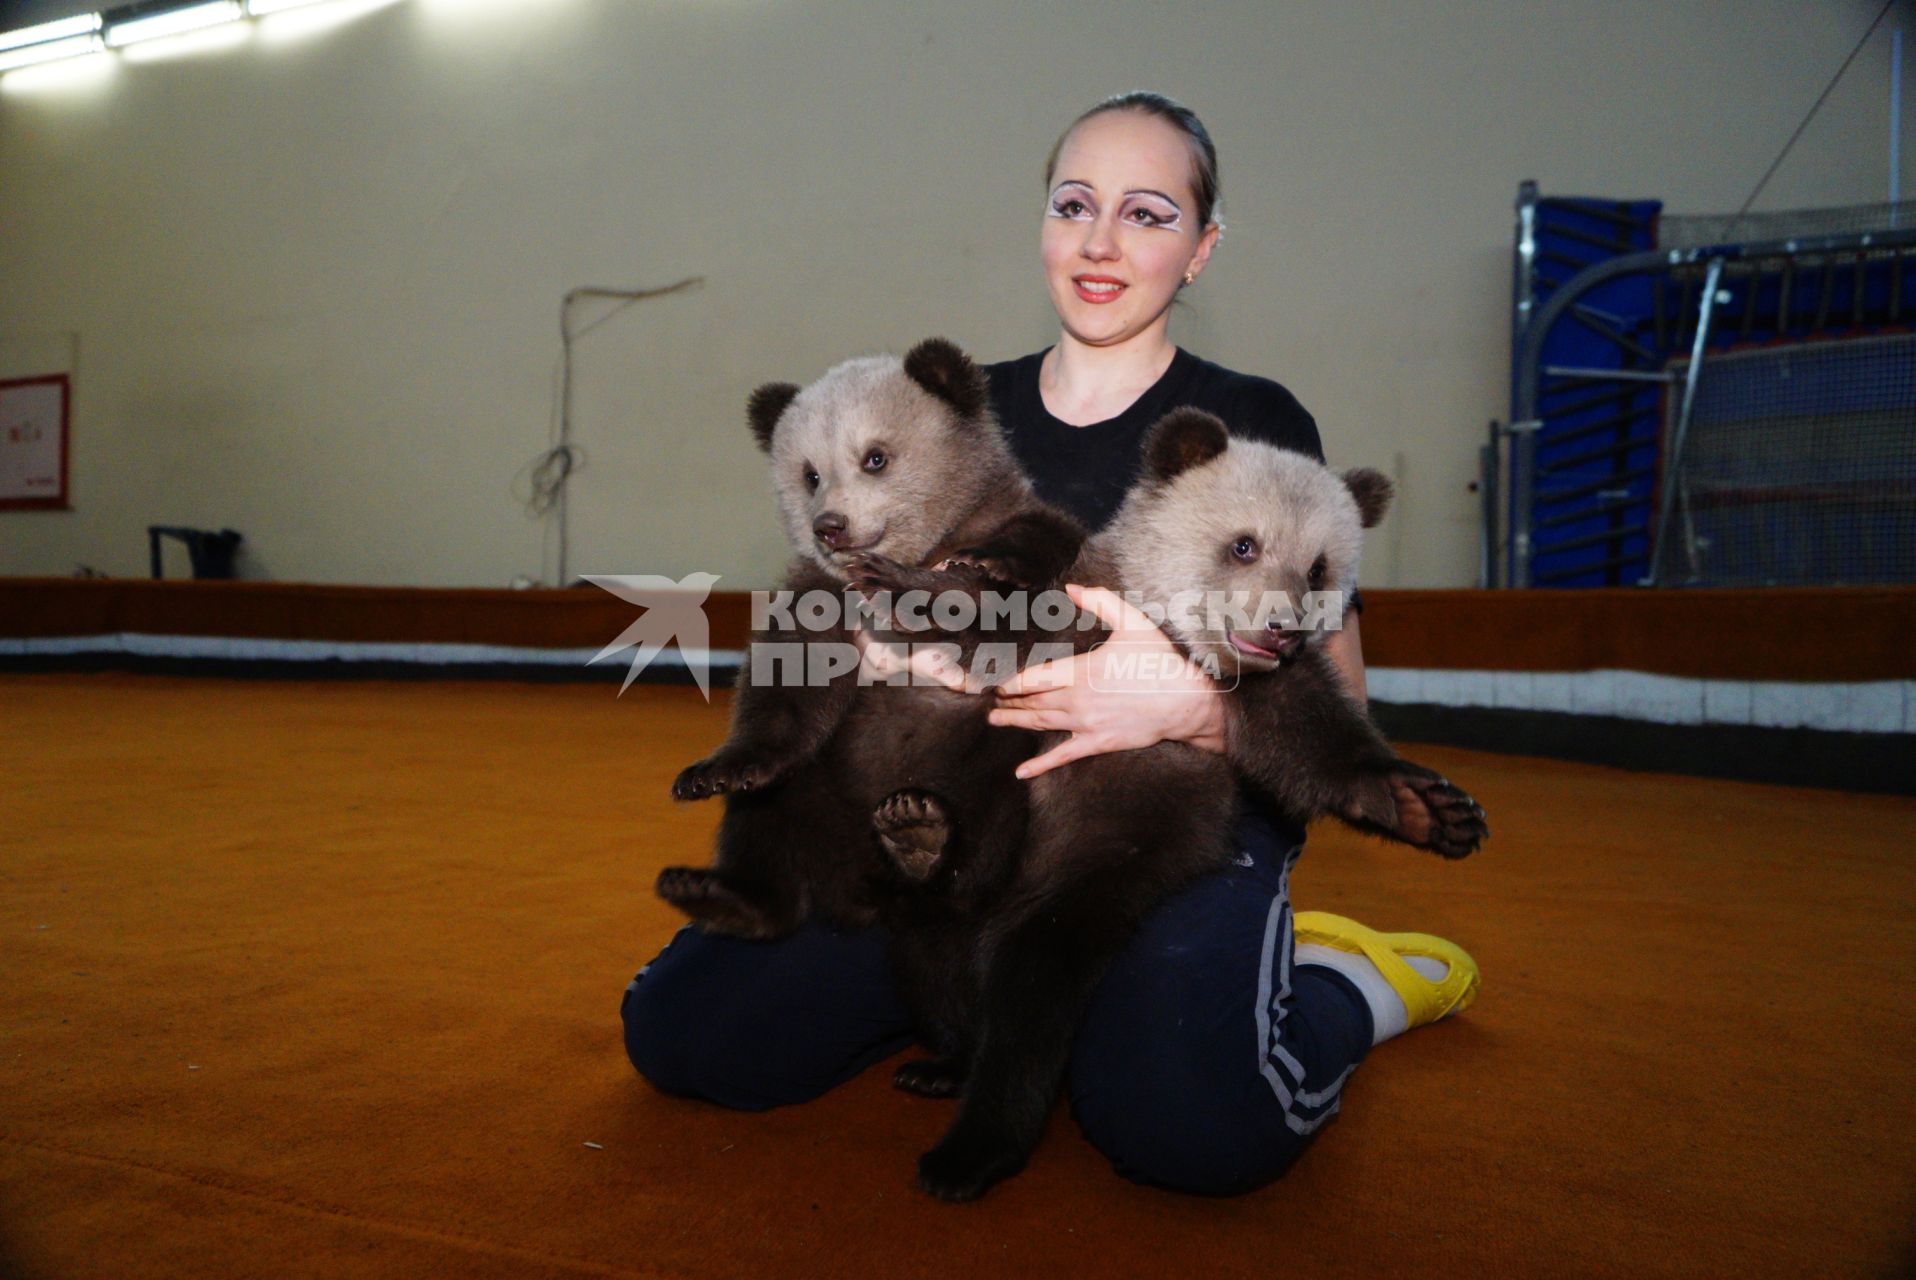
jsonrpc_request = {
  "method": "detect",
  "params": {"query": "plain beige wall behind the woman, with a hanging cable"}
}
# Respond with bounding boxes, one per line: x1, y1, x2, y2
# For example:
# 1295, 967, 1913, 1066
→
0, 0, 1893, 588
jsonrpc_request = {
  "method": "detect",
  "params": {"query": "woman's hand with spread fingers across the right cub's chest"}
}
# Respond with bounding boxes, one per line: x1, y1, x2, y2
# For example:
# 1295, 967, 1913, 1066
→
991, 584, 1224, 778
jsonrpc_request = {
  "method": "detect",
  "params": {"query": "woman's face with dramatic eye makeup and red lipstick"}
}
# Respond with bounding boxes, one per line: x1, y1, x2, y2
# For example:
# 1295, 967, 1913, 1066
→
1040, 111, 1217, 347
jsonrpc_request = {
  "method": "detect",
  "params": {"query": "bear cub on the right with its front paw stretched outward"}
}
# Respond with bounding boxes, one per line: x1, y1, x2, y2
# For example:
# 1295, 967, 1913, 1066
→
855, 410, 1487, 1200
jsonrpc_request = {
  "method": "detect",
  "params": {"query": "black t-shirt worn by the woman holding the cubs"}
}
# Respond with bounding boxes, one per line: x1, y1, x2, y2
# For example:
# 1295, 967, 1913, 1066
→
985, 347, 1324, 531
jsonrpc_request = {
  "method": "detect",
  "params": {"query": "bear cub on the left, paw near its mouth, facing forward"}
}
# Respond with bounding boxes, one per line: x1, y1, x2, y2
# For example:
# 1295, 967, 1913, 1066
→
657, 339, 1084, 937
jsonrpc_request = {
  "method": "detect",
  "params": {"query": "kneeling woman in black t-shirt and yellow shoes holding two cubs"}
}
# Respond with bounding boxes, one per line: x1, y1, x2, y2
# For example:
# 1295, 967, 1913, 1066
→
623, 94, 1477, 1194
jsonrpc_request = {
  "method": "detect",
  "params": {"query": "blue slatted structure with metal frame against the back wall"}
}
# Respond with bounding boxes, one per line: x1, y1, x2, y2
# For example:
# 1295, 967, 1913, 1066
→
1485, 182, 1916, 586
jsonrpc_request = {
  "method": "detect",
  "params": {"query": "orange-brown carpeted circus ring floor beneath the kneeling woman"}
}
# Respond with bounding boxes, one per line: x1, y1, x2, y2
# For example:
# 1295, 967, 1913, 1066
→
0, 674, 1916, 1280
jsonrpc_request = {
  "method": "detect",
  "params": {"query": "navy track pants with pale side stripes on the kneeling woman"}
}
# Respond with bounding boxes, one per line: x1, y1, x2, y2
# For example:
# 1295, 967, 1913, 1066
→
621, 814, 1372, 1196
